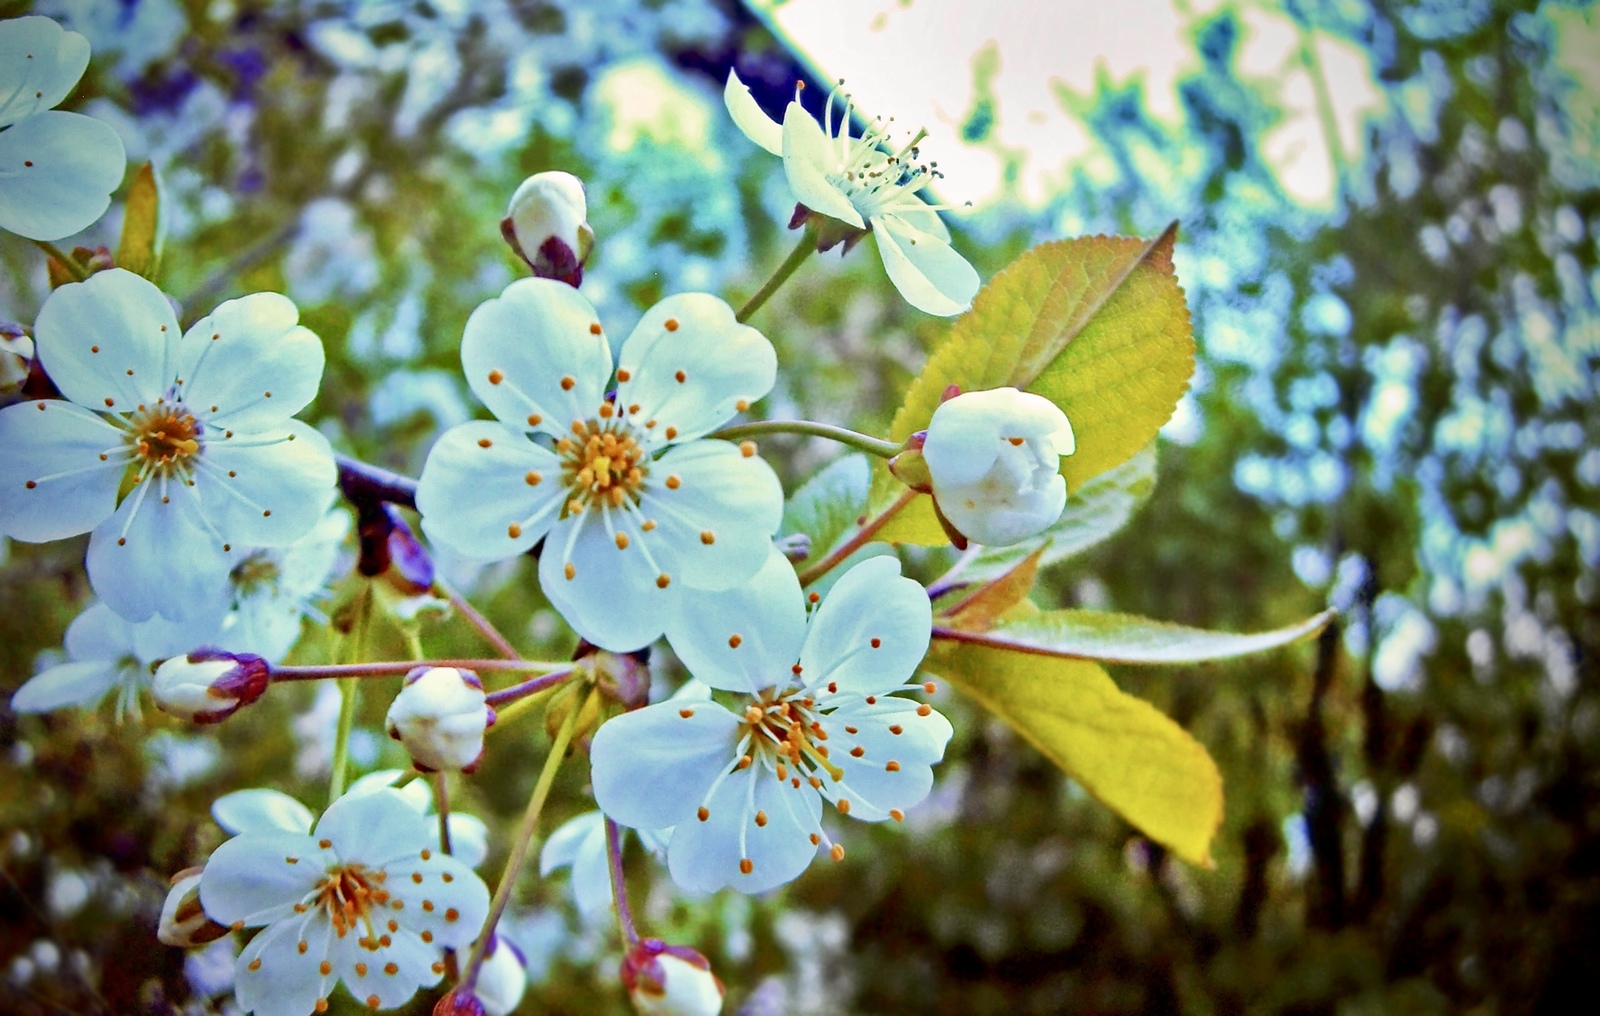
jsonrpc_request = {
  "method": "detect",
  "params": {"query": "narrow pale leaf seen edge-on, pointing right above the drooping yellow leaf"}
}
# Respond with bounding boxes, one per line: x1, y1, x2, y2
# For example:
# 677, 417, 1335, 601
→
934, 610, 1334, 664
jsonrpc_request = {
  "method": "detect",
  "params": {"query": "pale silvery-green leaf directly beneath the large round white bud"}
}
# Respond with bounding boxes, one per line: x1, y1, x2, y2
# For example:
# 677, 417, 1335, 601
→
962, 442, 1155, 581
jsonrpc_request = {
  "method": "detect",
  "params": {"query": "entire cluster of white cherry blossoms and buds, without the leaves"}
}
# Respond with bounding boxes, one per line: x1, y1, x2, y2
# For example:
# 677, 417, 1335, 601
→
0, 18, 1074, 1016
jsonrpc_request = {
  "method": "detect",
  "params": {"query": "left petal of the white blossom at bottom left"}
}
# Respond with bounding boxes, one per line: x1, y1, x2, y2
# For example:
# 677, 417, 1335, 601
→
200, 830, 331, 928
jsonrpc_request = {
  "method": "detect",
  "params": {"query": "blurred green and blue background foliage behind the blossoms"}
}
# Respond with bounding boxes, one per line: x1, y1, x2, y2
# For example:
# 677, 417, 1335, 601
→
0, 0, 1600, 1014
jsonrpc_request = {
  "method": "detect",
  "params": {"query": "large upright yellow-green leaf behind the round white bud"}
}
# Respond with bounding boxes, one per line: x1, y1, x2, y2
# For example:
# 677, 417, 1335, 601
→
872, 222, 1194, 546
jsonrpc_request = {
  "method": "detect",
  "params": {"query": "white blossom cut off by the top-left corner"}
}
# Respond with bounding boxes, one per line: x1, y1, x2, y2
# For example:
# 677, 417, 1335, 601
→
0, 16, 128, 240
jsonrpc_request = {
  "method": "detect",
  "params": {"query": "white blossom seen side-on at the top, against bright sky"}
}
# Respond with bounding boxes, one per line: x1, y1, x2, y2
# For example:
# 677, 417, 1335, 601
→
722, 70, 979, 317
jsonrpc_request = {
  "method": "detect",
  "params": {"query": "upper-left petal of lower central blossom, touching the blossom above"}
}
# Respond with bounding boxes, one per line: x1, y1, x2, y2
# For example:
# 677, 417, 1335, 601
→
667, 550, 806, 694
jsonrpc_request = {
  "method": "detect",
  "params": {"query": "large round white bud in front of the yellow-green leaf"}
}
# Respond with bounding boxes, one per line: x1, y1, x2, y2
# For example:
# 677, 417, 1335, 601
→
922, 387, 1075, 547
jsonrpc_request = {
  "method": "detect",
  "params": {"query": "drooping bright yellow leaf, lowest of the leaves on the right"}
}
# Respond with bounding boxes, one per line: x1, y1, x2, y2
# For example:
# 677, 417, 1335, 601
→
923, 638, 1222, 867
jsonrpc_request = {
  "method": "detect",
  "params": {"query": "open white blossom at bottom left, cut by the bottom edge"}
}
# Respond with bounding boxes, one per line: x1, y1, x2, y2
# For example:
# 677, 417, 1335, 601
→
200, 789, 490, 1016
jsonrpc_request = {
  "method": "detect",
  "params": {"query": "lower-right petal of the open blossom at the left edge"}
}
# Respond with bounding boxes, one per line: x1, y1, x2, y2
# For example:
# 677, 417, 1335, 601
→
200, 419, 339, 550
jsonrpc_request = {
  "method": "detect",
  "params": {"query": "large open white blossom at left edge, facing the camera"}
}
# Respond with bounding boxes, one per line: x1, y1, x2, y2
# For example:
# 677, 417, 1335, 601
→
0, 269, 334, 621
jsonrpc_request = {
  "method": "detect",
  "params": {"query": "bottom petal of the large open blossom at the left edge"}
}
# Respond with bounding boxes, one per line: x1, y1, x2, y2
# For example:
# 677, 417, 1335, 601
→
83, 480, 238, 621
